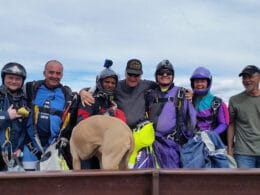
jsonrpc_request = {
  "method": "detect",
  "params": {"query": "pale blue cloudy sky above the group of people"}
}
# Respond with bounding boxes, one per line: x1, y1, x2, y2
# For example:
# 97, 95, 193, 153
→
0, 0, 260, 102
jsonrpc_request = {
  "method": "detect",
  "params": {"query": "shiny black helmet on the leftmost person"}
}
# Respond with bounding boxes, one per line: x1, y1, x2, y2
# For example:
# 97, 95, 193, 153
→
1, 62, 26, 83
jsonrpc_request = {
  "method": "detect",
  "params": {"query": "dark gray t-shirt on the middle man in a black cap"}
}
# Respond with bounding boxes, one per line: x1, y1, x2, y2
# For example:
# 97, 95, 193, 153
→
116, 79, 155, 129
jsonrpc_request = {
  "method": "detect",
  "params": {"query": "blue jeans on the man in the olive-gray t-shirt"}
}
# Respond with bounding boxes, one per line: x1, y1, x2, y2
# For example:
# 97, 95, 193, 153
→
234, 154, 260, 168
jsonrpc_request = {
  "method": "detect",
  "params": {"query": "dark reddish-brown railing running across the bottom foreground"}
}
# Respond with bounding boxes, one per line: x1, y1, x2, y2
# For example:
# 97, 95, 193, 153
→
0, 169, 260, 195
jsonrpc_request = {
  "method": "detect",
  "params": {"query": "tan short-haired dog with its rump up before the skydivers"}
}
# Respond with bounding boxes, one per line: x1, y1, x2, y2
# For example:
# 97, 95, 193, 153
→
70, 115, 134, 170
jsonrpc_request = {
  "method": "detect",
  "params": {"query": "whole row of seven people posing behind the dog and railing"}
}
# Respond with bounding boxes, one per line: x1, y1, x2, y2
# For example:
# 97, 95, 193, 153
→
0, 59, 260, 171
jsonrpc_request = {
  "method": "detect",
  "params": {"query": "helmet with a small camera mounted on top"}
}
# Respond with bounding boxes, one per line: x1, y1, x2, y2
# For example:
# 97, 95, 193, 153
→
96, 60, 118, 95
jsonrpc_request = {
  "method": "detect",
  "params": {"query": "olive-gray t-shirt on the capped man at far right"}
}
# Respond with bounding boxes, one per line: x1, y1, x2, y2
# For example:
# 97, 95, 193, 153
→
229, 92, 260, 156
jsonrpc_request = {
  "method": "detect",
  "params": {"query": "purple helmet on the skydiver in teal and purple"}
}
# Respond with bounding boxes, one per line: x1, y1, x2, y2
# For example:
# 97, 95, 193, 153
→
190, 66, 212, 95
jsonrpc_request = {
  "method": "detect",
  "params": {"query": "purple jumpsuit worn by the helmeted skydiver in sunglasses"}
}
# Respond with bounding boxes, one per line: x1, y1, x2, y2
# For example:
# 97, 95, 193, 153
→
147, 87, 196, 168
